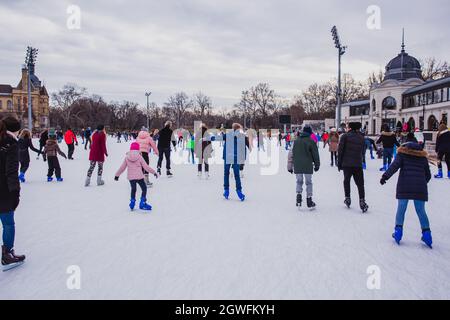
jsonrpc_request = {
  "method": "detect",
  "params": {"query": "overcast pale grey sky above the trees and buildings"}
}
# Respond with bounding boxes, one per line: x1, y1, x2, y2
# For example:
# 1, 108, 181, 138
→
0, 0, 450, 107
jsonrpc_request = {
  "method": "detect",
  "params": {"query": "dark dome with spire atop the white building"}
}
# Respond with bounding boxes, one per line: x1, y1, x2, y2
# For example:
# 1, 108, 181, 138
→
384, 32, 423, 81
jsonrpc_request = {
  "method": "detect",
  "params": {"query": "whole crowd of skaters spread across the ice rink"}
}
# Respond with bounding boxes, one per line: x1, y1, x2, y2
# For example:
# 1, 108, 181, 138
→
0, 117, 450, 265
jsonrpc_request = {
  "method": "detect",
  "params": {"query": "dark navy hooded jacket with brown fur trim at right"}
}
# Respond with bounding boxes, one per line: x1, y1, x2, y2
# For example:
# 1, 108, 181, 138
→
383, 142, 431, 201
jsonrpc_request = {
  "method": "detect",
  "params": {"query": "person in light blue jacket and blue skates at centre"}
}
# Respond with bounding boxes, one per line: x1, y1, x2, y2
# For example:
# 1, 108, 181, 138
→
223, 123, 250, 201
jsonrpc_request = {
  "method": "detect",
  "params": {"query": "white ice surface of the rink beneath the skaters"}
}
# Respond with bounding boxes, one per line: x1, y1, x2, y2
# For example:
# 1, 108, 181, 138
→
0, 139, 450, 299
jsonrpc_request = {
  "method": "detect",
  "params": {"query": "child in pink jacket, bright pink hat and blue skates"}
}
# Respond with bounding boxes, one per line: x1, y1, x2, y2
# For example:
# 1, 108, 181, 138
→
114, 142, 158, 211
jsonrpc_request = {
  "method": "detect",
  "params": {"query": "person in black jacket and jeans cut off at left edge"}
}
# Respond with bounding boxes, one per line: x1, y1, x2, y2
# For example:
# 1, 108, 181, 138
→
0, 117, 25, 271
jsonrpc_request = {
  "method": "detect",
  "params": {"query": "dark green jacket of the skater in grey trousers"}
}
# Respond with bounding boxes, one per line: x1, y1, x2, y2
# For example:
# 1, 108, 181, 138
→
288, 133, 320, 174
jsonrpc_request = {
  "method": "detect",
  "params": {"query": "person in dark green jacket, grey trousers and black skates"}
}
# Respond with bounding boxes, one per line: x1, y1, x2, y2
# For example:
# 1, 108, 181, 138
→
288, 127, 320, 209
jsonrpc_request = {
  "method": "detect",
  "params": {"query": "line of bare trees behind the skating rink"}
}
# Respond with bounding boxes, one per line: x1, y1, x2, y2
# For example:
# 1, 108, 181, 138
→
50, 58, 450, 130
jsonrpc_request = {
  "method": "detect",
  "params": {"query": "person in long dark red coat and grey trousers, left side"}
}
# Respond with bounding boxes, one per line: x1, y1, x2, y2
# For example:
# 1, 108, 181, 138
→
84, 125, 108, 187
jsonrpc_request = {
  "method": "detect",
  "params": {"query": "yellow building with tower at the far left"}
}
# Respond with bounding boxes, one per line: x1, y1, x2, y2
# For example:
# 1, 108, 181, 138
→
0, 66, 49, 128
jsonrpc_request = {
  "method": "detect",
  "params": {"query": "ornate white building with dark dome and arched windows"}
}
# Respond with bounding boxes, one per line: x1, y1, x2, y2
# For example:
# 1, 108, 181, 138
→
342, 39, 450, 135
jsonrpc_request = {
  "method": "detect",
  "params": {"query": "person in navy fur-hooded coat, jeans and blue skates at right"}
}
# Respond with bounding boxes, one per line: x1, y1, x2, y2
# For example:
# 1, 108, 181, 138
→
380, 142, 433, 248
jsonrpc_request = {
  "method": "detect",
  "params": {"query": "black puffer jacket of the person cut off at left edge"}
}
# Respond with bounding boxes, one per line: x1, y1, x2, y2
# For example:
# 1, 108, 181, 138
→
0, 134, 20, 214
